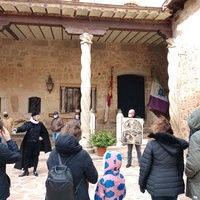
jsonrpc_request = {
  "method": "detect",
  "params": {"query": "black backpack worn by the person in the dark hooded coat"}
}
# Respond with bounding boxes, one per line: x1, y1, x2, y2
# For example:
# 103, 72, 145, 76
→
45, 153, 83, 200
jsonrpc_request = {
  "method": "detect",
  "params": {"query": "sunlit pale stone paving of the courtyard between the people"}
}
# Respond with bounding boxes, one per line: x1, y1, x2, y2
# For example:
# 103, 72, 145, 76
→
7, 147, 189, 200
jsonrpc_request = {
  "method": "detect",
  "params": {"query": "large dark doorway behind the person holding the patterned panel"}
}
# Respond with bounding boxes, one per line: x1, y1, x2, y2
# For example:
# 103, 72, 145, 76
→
117, 75, 145, 118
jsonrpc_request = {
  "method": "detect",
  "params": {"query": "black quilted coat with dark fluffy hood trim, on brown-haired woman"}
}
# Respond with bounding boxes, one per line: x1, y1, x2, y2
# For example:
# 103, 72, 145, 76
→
139, 133, 188, 196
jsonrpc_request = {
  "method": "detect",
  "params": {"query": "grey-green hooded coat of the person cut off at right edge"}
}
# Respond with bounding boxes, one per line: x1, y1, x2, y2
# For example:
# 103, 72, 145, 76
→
185, 109, 200, 199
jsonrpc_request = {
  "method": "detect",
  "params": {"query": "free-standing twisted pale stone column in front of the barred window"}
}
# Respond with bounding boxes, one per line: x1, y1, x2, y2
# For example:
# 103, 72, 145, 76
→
79, 33, 93, 147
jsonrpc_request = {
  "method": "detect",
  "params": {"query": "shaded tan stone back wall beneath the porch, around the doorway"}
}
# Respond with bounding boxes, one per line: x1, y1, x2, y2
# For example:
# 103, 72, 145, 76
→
0, 38, 168, 131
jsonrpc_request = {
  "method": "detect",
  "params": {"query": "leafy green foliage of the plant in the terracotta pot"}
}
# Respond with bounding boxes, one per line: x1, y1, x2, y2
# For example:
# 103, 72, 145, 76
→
91, 131, 116, 147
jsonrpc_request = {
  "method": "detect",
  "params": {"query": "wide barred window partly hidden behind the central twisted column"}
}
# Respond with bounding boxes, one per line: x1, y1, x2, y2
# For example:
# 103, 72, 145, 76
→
60, 86, 96, 113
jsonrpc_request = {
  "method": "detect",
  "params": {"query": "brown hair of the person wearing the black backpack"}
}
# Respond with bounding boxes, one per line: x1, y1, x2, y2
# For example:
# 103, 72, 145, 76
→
61, 121, 82, 141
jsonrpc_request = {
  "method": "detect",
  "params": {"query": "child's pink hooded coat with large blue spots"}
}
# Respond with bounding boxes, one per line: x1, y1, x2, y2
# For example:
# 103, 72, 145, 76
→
94, 151, 126, 200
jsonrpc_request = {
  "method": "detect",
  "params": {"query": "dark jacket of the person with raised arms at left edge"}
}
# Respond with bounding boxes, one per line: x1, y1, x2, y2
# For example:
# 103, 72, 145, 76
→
0, 140, 21, 200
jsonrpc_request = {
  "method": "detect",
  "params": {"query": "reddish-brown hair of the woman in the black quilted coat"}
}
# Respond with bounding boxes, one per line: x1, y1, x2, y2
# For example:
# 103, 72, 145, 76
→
151, 115, 173, 134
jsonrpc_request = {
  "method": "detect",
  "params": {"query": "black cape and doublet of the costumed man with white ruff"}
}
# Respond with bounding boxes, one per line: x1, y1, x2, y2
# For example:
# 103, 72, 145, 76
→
14, 121, 52, 169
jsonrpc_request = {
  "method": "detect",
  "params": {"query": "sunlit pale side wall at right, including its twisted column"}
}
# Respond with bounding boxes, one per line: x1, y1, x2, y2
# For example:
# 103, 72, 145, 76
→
168, 0, 200, 139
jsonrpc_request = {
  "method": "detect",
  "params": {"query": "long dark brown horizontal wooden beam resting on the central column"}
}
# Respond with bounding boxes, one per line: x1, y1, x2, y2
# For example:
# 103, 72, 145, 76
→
0, 14, 172, 35
